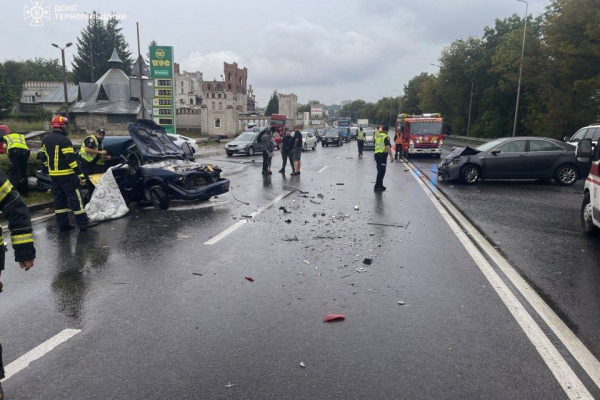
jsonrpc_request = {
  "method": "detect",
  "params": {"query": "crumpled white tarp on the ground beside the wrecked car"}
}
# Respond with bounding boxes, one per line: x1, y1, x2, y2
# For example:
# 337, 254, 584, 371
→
85, 167, 129, 222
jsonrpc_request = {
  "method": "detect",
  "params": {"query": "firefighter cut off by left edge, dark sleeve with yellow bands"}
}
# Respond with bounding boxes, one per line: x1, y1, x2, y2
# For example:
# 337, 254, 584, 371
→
0, 171, 35, 400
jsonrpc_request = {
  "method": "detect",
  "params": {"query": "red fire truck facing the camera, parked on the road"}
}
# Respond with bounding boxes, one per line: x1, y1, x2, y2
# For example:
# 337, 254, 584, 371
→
396, 113, 445, 158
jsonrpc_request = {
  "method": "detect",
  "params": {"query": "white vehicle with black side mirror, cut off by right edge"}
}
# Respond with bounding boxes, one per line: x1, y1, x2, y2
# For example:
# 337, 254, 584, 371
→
576, 138, 600, 236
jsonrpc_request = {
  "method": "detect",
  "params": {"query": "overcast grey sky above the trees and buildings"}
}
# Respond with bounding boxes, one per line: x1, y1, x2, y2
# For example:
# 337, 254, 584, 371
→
5, 0, 546, 106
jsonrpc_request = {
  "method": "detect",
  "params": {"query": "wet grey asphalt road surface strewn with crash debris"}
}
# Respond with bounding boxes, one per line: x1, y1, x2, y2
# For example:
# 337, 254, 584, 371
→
0, 143, 598, 399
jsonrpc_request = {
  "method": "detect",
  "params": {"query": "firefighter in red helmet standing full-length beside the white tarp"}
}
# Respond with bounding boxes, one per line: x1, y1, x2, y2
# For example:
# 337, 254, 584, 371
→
41, 115, 98, 231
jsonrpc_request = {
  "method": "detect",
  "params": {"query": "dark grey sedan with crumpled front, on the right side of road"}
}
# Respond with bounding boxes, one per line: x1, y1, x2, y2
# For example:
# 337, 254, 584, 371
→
438, 137, 589, 186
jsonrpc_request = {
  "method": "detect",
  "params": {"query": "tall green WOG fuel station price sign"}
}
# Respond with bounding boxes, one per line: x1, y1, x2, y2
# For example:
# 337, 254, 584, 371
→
150, 46, 176, 133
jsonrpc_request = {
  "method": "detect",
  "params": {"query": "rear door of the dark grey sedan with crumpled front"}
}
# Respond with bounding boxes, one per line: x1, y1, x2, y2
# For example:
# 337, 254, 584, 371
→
526, 139, 567, 179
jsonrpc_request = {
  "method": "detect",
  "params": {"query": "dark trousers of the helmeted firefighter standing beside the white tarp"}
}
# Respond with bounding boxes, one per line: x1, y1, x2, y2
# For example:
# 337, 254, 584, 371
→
51, 174, 90, 227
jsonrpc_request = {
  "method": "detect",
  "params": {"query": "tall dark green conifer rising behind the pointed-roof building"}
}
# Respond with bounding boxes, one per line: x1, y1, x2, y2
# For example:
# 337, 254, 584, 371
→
72, 11, 135, 83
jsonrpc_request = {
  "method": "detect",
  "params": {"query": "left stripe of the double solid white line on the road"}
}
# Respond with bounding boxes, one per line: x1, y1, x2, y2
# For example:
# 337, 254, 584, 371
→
407, 163, 593, 399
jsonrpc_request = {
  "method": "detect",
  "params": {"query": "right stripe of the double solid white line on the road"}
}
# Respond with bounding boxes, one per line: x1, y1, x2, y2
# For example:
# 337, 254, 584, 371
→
410, 161, 600, 388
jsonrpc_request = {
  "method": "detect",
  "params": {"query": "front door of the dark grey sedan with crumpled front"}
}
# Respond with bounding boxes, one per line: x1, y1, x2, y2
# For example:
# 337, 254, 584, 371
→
483, 139, 527, 179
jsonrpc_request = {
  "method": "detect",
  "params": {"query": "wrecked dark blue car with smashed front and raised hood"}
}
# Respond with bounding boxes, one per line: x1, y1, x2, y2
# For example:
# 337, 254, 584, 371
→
36, 120, 229, 210
